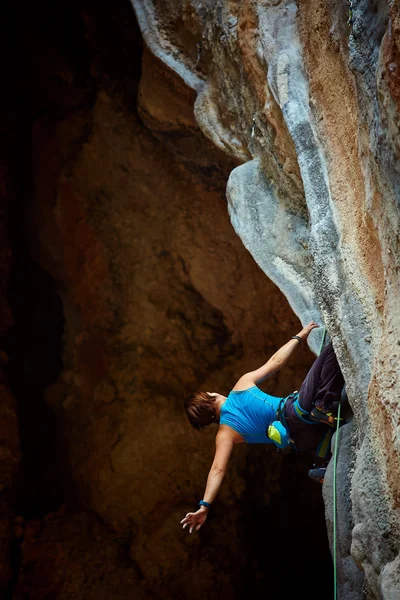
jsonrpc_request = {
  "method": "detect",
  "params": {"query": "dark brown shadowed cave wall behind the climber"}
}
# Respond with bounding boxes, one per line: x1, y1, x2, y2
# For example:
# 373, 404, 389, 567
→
5, 0, 332, 600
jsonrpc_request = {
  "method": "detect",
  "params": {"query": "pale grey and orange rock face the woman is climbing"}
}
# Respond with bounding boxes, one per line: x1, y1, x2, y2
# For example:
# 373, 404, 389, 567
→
133, 0, 400, 599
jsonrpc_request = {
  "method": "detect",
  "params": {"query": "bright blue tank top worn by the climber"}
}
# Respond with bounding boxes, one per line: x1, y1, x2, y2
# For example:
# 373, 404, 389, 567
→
219, 385, 282, 444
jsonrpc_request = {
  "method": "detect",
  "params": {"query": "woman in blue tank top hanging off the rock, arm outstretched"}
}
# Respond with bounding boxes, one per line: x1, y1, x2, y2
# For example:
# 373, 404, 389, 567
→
181, 321, 344, 533
